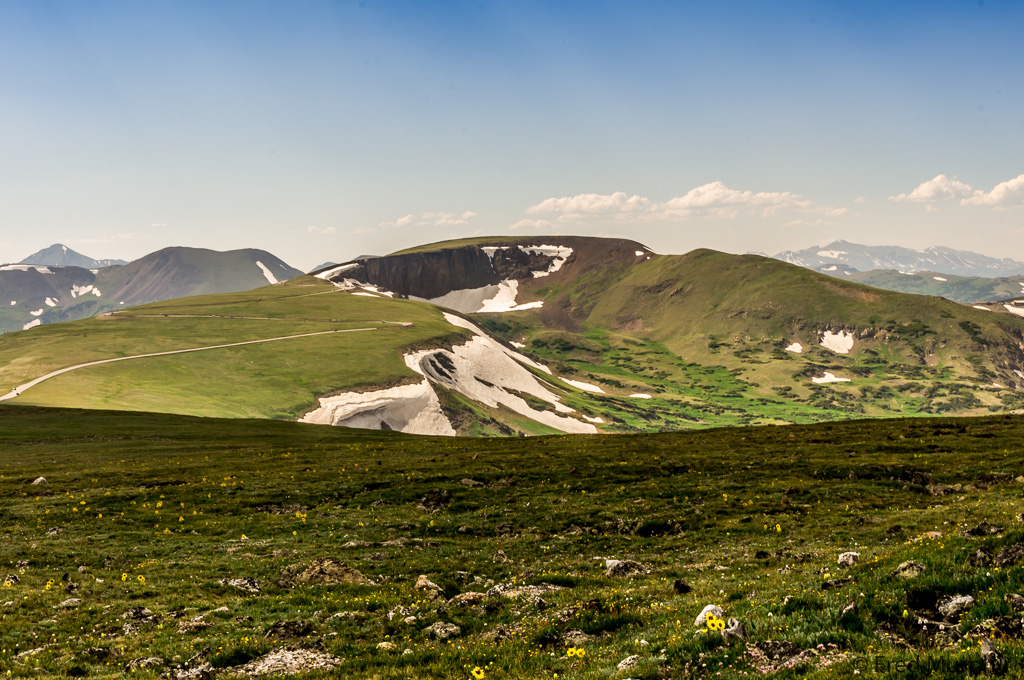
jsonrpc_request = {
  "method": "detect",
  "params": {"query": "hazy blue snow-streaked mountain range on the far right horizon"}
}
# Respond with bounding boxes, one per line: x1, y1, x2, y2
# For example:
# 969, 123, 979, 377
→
772, 241, 1024, 278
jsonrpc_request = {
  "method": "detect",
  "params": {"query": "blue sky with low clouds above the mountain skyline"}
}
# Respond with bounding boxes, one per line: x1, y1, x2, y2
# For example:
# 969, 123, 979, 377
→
0, 0, 1024, 267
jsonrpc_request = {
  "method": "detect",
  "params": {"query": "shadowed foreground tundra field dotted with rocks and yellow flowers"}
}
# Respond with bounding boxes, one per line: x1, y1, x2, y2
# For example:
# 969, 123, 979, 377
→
0, 406, 1024, 678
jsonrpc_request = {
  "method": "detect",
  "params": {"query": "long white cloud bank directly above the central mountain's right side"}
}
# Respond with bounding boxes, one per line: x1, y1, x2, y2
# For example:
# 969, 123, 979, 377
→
526, 181, 846, 222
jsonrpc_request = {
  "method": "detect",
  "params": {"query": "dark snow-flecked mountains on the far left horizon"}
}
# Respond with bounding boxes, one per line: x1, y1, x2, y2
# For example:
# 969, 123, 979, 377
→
0, 244, 302, 333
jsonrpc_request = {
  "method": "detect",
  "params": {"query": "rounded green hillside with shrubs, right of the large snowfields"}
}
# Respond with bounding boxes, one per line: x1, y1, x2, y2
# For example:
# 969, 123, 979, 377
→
473, 246, 1024, 426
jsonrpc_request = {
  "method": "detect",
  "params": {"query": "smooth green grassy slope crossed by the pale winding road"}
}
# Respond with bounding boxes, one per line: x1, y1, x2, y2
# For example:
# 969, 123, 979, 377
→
0, 278, 465, 418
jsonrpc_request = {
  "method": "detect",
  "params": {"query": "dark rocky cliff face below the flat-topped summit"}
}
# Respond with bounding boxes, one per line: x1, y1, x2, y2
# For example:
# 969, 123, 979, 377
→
334, 246, 552, 298
